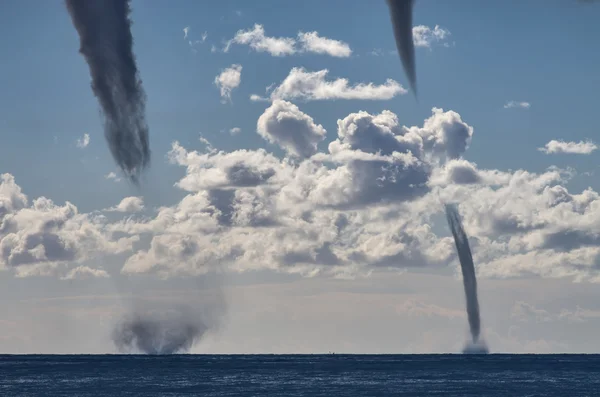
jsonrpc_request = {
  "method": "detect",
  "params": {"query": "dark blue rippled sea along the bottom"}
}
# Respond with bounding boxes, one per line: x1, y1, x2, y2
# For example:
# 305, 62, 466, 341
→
0, 355, 600, 397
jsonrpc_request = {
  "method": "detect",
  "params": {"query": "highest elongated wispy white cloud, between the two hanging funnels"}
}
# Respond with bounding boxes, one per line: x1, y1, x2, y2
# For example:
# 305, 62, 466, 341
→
223, 24, 352, 58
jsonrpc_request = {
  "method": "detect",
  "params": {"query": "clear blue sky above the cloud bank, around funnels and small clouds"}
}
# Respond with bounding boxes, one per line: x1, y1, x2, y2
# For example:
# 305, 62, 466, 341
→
0, 0, 600, 209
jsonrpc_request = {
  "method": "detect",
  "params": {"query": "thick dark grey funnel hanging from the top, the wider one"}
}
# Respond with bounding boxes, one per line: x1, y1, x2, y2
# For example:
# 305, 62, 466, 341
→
66, 0, 150, 184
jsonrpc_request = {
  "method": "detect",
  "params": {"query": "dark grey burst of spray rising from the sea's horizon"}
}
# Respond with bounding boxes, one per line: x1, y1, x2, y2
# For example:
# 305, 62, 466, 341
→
112, 306, 210, 354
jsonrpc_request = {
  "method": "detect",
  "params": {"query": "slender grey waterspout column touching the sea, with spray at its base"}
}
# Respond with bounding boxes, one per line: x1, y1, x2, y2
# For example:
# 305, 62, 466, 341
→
445, 204, 487, 353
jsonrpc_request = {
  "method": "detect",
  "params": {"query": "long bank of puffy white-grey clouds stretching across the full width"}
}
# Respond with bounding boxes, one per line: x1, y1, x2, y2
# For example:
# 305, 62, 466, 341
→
8, 103, 600, 284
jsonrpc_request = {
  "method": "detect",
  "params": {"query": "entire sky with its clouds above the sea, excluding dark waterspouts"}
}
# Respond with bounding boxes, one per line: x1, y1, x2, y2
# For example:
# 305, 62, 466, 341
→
0, 0, 600, 353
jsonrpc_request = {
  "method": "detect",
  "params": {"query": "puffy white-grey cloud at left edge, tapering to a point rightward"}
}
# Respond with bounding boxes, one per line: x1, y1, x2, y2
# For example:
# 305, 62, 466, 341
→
0, 174, 138, 276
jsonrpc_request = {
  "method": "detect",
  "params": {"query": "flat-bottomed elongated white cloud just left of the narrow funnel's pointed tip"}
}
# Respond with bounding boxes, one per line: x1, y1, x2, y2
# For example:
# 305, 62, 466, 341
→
250, 68, 407, 101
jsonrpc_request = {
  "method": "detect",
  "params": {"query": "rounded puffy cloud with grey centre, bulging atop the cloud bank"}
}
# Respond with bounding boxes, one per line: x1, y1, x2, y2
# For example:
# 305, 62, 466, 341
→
256, 100, 327, 157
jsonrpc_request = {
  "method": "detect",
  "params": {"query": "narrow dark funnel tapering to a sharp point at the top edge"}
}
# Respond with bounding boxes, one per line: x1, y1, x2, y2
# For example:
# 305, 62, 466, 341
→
386, 0, 417, 97
